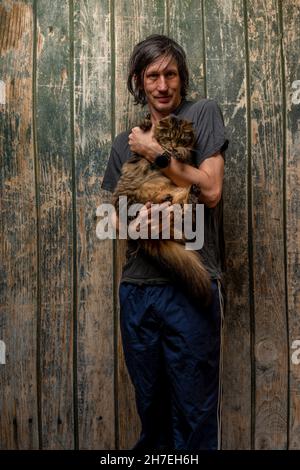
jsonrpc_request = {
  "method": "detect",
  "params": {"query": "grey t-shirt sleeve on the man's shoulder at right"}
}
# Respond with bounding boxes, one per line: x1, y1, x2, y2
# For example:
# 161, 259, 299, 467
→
193, 100, 229, 165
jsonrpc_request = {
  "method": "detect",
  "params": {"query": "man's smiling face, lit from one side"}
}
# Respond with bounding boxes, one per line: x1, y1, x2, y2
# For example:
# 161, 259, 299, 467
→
144, 56, 181, 118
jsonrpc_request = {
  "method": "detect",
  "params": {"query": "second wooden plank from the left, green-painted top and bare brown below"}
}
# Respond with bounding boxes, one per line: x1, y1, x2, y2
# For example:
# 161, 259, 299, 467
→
36, 0, 74, 449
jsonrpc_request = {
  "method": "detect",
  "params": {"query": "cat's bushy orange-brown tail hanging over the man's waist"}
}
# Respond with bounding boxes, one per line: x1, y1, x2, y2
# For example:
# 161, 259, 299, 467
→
140, 240, 211, 305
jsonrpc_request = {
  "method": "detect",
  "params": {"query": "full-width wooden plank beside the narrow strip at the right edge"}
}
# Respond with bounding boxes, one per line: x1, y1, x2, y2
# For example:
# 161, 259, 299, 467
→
248, 0, 288, 449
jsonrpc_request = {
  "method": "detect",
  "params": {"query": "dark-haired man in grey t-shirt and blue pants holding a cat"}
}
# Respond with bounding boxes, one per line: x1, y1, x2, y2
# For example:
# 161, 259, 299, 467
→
102, 35, 228, 451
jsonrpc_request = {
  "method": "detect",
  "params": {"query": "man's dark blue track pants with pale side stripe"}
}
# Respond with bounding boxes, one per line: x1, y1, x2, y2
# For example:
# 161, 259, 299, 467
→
119, 280, 223, 451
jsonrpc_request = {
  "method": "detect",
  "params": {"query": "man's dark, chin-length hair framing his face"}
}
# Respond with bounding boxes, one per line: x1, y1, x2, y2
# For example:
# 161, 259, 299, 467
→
127, 34, 189, 106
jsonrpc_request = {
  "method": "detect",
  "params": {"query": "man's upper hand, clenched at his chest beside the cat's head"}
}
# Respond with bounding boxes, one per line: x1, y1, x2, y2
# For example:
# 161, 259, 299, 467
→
128, 125, 163, 163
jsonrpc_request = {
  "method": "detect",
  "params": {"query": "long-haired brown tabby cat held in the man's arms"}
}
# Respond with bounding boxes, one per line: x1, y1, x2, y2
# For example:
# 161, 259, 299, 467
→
113, 116, 211, 303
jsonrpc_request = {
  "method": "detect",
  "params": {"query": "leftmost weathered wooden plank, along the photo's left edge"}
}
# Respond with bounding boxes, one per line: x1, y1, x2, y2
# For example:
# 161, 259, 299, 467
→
0, 1, 39, 449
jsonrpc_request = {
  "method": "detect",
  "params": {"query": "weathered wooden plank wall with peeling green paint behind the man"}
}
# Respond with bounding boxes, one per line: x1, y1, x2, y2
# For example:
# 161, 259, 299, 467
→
0, 0, 300, 449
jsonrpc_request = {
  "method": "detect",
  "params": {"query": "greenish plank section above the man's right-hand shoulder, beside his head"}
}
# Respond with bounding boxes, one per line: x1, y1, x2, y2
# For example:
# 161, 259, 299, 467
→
168, 0, 205, 100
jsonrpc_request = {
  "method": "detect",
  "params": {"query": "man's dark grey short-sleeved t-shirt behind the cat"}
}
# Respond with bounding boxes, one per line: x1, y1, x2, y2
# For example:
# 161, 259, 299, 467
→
102, 99, 228, 284
